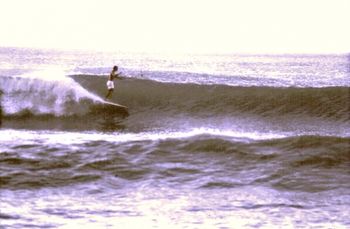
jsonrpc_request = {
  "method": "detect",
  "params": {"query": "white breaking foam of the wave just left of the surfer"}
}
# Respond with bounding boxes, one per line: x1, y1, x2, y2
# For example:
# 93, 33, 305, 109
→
0, 68, 102, 116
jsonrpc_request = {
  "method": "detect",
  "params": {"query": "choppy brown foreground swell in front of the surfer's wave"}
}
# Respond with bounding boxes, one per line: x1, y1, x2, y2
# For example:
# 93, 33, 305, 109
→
0, 133, 350, 192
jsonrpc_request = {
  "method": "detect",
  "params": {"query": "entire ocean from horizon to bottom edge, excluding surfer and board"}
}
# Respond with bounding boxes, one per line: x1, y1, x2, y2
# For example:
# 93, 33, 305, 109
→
0, 47, 350, 228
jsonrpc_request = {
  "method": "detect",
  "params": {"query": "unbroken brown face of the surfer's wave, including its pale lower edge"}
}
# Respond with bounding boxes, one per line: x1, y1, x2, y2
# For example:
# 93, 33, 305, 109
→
73, 75, 350, 133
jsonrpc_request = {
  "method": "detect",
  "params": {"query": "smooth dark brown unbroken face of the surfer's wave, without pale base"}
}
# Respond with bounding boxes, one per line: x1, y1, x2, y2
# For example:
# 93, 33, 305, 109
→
72, 75, 350, 122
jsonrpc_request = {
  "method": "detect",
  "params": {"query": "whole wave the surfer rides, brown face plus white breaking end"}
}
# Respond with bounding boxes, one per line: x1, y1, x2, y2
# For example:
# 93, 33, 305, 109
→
0, 71, 350, 136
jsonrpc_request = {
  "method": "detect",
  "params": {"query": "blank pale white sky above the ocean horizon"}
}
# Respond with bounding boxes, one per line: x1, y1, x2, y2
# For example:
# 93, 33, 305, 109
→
0, 0, 350, 53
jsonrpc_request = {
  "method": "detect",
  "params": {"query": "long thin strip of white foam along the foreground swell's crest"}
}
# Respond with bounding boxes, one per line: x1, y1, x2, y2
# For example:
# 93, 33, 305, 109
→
0, 128, 287, 148
